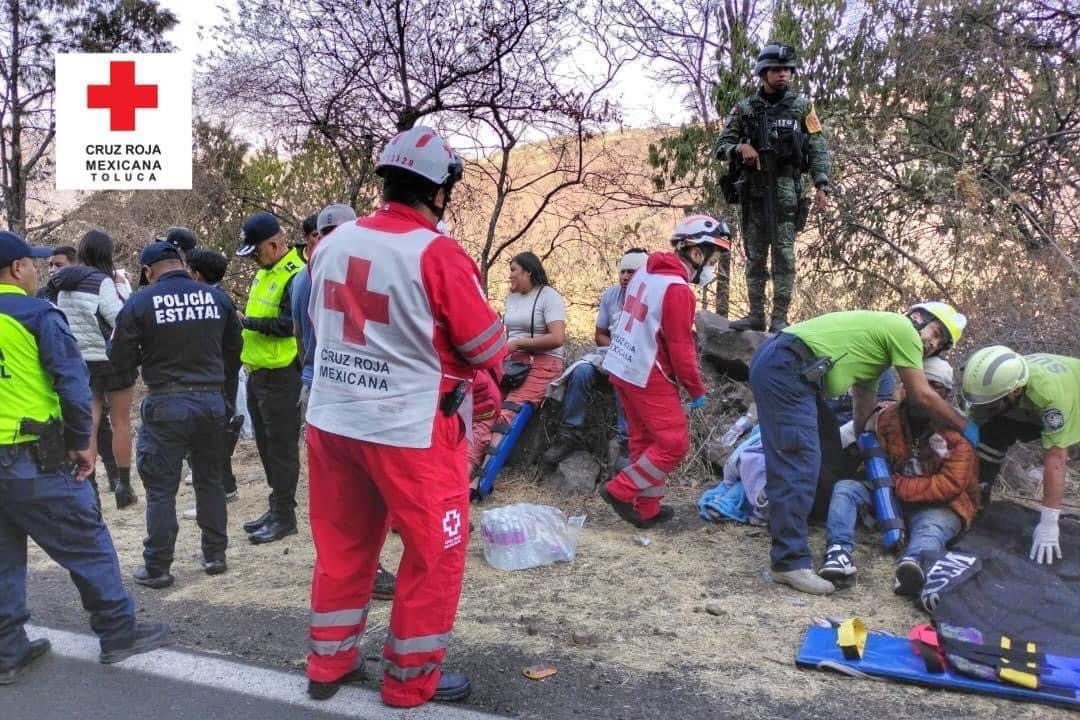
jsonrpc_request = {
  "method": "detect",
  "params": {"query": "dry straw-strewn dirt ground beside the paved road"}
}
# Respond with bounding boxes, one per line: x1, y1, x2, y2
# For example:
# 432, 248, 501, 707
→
23, 427, 1068, 718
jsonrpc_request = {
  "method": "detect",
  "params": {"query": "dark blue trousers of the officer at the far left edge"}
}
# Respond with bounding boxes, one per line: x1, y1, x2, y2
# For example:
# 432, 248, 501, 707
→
0, 446, 135, 669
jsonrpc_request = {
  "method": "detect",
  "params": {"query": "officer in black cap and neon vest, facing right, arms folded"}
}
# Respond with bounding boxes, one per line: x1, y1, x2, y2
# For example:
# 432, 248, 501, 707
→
237, 213, 303, 544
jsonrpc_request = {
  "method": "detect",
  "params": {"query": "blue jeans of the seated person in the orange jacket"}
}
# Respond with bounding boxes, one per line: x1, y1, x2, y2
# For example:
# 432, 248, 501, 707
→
825, 480, 963, 560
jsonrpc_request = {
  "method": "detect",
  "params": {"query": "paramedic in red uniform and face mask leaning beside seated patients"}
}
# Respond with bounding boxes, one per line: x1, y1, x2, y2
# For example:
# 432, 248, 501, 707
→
600, 215, 731, 528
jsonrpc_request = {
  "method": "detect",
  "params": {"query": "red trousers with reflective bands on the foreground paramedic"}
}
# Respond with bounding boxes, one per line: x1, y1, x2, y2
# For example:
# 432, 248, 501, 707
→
308, 413, 469, 707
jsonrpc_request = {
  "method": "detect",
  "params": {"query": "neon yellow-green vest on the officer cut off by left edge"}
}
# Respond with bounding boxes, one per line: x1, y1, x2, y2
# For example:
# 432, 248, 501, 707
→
0, 285, 60, 445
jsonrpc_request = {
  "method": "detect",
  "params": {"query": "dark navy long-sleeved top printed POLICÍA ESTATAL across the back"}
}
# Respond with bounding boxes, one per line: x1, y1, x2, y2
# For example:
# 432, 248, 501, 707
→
109, 270, 242, 390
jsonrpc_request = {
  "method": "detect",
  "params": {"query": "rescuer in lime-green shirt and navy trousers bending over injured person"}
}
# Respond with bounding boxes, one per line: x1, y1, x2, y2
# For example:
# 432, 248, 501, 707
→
750, 302, 978, 595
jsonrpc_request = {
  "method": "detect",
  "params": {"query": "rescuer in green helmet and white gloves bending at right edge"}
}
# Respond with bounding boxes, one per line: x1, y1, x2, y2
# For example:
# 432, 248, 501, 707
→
962, 345, 1080, 565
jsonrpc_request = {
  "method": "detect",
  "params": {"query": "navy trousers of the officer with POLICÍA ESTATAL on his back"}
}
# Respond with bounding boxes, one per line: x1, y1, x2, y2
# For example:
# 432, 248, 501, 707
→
135, 392, 228, 574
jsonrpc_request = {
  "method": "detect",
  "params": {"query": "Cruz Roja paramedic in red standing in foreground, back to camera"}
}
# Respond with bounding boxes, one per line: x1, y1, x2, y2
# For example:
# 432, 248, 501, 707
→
307, 126, 505, 707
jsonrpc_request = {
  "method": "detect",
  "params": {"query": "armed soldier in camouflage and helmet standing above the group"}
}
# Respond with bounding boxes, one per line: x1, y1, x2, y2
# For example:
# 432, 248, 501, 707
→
716, 43, 831, 332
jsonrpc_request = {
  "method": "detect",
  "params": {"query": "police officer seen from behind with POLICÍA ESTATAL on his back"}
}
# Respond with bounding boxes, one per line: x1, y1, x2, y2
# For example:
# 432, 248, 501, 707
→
109, 242, 241, 588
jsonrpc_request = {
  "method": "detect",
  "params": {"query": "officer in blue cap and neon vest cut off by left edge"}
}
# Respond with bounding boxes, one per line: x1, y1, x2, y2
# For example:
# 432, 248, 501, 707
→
0, 231, 168, 684
